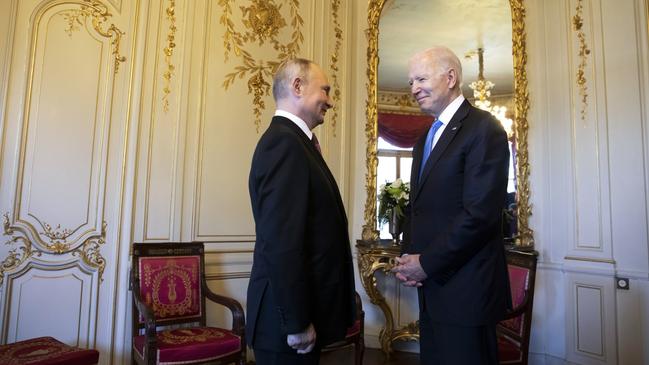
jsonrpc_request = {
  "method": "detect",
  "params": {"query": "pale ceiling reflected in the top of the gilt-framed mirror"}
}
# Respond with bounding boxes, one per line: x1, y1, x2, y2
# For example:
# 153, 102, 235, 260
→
378, 0, 514, 98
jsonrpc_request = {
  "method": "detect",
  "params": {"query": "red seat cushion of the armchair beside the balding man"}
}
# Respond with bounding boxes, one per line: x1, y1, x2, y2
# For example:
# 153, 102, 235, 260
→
133, 327, 241, 365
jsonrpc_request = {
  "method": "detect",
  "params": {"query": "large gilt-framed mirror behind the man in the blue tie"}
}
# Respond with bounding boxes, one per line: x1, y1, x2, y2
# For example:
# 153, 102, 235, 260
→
362, 0, 533, 247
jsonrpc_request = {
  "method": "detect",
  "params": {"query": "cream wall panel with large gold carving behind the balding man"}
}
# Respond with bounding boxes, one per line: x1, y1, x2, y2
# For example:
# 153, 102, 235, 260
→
192, 1, 316, 241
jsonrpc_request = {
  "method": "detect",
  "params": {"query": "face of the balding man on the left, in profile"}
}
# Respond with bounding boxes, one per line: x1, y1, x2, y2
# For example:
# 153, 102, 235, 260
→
300, 65, 332, 129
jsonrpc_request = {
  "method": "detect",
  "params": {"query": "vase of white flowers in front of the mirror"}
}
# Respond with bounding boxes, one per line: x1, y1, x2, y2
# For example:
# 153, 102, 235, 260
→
378, 179, 410, 245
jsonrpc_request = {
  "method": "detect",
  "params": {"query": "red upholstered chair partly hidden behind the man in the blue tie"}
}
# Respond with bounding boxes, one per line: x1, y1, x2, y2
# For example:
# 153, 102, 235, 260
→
496, 248, 538, 365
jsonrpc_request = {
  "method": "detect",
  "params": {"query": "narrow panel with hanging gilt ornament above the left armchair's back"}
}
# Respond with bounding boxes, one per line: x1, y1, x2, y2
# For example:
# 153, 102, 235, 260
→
135, 0, 193, 241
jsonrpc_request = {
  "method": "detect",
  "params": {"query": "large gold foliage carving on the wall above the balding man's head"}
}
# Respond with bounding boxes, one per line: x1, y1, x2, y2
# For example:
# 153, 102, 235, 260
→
219, 0, 304, 132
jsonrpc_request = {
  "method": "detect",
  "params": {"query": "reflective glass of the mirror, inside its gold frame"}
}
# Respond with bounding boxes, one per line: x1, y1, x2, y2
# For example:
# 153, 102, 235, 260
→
376, 0, 517, 241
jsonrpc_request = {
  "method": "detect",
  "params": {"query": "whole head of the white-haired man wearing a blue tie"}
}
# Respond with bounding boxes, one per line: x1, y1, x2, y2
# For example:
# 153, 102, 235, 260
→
408, 51, 460, 117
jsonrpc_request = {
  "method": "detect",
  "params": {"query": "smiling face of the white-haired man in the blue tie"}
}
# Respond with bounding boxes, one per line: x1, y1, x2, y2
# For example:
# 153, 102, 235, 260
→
408, 57, 455, 117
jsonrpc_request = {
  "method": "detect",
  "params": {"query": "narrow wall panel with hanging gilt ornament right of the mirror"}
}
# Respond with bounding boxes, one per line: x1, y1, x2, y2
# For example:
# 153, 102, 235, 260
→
566, 0, 612, 259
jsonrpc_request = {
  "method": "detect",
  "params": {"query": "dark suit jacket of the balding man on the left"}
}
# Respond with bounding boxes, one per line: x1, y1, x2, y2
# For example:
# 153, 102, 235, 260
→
246, 116, 355, 352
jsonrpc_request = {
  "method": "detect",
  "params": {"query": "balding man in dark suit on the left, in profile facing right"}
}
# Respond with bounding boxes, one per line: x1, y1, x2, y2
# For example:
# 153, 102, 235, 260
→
246, 59, 356, 365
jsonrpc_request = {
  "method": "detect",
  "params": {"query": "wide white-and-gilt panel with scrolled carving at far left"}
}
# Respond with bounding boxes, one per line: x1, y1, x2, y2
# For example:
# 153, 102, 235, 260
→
0, 0, 138, 365
